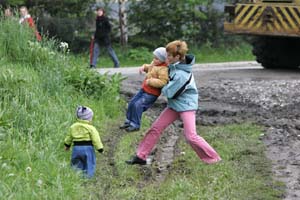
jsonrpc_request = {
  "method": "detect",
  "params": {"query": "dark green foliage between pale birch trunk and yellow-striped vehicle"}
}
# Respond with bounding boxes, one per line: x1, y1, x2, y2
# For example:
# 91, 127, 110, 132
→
129, 0, 239, 48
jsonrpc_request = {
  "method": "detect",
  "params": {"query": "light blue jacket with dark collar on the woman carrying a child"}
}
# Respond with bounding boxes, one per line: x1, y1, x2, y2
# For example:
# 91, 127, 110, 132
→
162, 55, 198, 112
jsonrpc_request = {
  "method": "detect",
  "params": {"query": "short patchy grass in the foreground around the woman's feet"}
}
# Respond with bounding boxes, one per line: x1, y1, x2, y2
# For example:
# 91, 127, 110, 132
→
85, 124, 283, 200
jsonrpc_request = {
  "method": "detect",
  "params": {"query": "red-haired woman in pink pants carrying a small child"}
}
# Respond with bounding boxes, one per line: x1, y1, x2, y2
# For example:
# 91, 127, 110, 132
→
126, 40, 221, 165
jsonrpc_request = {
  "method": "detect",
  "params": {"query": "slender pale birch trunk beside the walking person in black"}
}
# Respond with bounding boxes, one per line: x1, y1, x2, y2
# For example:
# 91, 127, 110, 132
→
118, 0, 128, 46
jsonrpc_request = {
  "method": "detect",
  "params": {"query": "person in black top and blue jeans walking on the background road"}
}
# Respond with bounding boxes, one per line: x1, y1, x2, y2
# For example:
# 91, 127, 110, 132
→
90, 8, 120, 68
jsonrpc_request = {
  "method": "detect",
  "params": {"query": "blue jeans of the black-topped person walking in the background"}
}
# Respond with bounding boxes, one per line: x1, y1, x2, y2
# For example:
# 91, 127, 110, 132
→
90, 42, 120, 68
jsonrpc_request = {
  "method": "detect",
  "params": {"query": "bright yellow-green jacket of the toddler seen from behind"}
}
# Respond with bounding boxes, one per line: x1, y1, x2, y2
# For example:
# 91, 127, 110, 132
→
65, 119, 103, 150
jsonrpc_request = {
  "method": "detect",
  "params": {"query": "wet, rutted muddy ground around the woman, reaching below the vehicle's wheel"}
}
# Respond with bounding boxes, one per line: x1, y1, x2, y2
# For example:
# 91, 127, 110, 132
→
114, 63, 300, 200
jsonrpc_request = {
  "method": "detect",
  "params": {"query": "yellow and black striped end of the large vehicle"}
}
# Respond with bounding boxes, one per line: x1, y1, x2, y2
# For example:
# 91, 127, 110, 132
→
224, 0, 300, 37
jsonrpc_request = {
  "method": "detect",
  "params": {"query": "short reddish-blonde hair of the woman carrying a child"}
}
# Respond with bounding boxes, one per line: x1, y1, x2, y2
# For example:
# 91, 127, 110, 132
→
166, 40, 188, 60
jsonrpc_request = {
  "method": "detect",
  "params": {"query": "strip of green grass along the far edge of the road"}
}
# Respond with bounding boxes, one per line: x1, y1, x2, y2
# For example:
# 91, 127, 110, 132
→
77, 43, 255, 68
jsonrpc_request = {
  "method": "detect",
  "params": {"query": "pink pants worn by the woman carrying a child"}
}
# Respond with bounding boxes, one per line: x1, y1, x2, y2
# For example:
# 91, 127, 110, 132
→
137, 108, 221, 164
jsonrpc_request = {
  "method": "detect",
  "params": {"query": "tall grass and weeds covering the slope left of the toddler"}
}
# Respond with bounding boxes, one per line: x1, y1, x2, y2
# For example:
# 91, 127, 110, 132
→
0, 19, 123, 199
